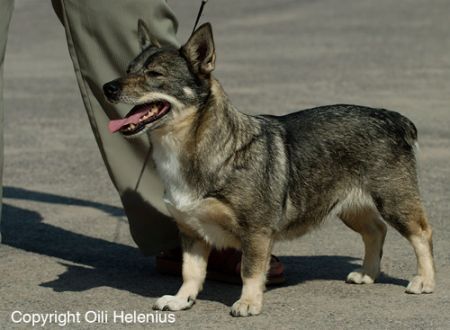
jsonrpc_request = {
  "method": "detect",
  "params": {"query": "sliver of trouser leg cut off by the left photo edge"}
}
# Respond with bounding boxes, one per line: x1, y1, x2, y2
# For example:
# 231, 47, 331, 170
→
0, 0, 14, 243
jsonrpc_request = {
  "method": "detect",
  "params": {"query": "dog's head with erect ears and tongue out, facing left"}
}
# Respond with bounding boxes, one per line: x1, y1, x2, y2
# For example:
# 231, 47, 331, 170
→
103, 20, 216, 137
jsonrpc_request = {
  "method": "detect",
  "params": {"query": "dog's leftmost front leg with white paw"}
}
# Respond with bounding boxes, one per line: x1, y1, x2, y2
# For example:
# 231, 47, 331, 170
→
153, 235, 211, 311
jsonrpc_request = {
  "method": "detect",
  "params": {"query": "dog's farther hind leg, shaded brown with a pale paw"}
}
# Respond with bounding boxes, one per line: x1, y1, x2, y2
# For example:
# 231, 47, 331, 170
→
339, 207, 387, 284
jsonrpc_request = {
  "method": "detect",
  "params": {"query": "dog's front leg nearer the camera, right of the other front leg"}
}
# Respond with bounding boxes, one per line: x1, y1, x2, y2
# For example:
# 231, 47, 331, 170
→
231, 235, 272, 316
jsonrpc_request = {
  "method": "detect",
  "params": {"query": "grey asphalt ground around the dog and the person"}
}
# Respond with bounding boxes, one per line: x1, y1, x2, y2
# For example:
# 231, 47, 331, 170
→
0, 0, 450, 329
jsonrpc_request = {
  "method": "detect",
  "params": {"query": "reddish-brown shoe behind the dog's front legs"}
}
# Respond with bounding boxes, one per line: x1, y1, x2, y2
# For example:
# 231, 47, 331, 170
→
156, 248, 286, 285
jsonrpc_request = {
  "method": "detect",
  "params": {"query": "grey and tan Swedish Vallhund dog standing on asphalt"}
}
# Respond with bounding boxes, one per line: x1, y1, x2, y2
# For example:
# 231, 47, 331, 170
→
104, 21, 435, 316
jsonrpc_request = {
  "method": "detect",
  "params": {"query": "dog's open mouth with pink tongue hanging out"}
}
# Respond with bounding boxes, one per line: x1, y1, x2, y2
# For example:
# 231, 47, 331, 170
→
108, 101, 170, 136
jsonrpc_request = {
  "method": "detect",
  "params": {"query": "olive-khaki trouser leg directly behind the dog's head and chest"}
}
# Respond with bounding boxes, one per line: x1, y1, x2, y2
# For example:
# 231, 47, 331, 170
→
52, 0, 179, 255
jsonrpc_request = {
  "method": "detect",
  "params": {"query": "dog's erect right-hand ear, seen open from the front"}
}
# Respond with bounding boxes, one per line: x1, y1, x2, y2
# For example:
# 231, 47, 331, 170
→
181, 23, 216, 75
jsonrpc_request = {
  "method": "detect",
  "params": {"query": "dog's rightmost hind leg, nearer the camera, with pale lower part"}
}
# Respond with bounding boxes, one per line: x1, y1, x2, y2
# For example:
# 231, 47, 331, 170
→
376, 190, 435, 294
